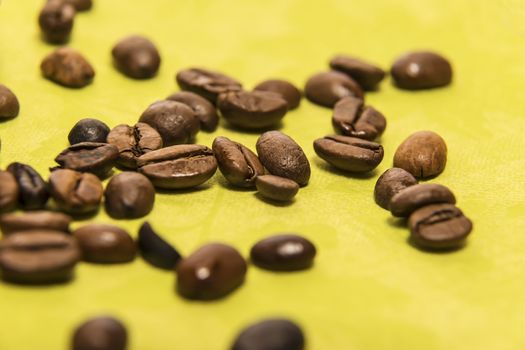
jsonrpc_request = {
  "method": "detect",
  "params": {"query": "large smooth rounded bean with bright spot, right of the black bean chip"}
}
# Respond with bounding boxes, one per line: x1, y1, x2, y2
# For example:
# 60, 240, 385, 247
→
177, 243, 247, 300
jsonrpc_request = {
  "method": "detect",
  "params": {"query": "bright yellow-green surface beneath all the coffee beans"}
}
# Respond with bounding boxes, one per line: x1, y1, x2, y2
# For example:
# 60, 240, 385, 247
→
0, 0, 525, 350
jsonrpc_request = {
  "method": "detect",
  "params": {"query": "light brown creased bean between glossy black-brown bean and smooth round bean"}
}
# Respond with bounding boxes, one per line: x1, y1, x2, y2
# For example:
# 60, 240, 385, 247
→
49, 169, 104, 214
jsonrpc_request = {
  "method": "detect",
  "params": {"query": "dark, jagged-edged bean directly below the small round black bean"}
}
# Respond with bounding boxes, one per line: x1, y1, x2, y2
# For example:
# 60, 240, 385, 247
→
55, 142, 119, 178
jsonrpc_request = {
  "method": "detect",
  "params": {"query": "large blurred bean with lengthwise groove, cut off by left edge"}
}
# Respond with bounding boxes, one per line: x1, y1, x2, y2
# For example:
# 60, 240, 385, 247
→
0, 230, 80, 284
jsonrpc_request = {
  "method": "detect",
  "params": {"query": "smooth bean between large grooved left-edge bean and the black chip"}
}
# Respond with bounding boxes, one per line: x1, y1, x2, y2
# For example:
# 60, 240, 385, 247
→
73, 224, 137, 264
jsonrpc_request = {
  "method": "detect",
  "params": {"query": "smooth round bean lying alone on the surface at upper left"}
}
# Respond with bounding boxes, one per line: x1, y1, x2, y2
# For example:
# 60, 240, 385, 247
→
111, 35, 160, 79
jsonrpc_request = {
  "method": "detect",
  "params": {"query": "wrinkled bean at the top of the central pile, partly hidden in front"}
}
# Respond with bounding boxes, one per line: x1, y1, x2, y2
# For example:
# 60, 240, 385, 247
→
176, 68, 242, 104
